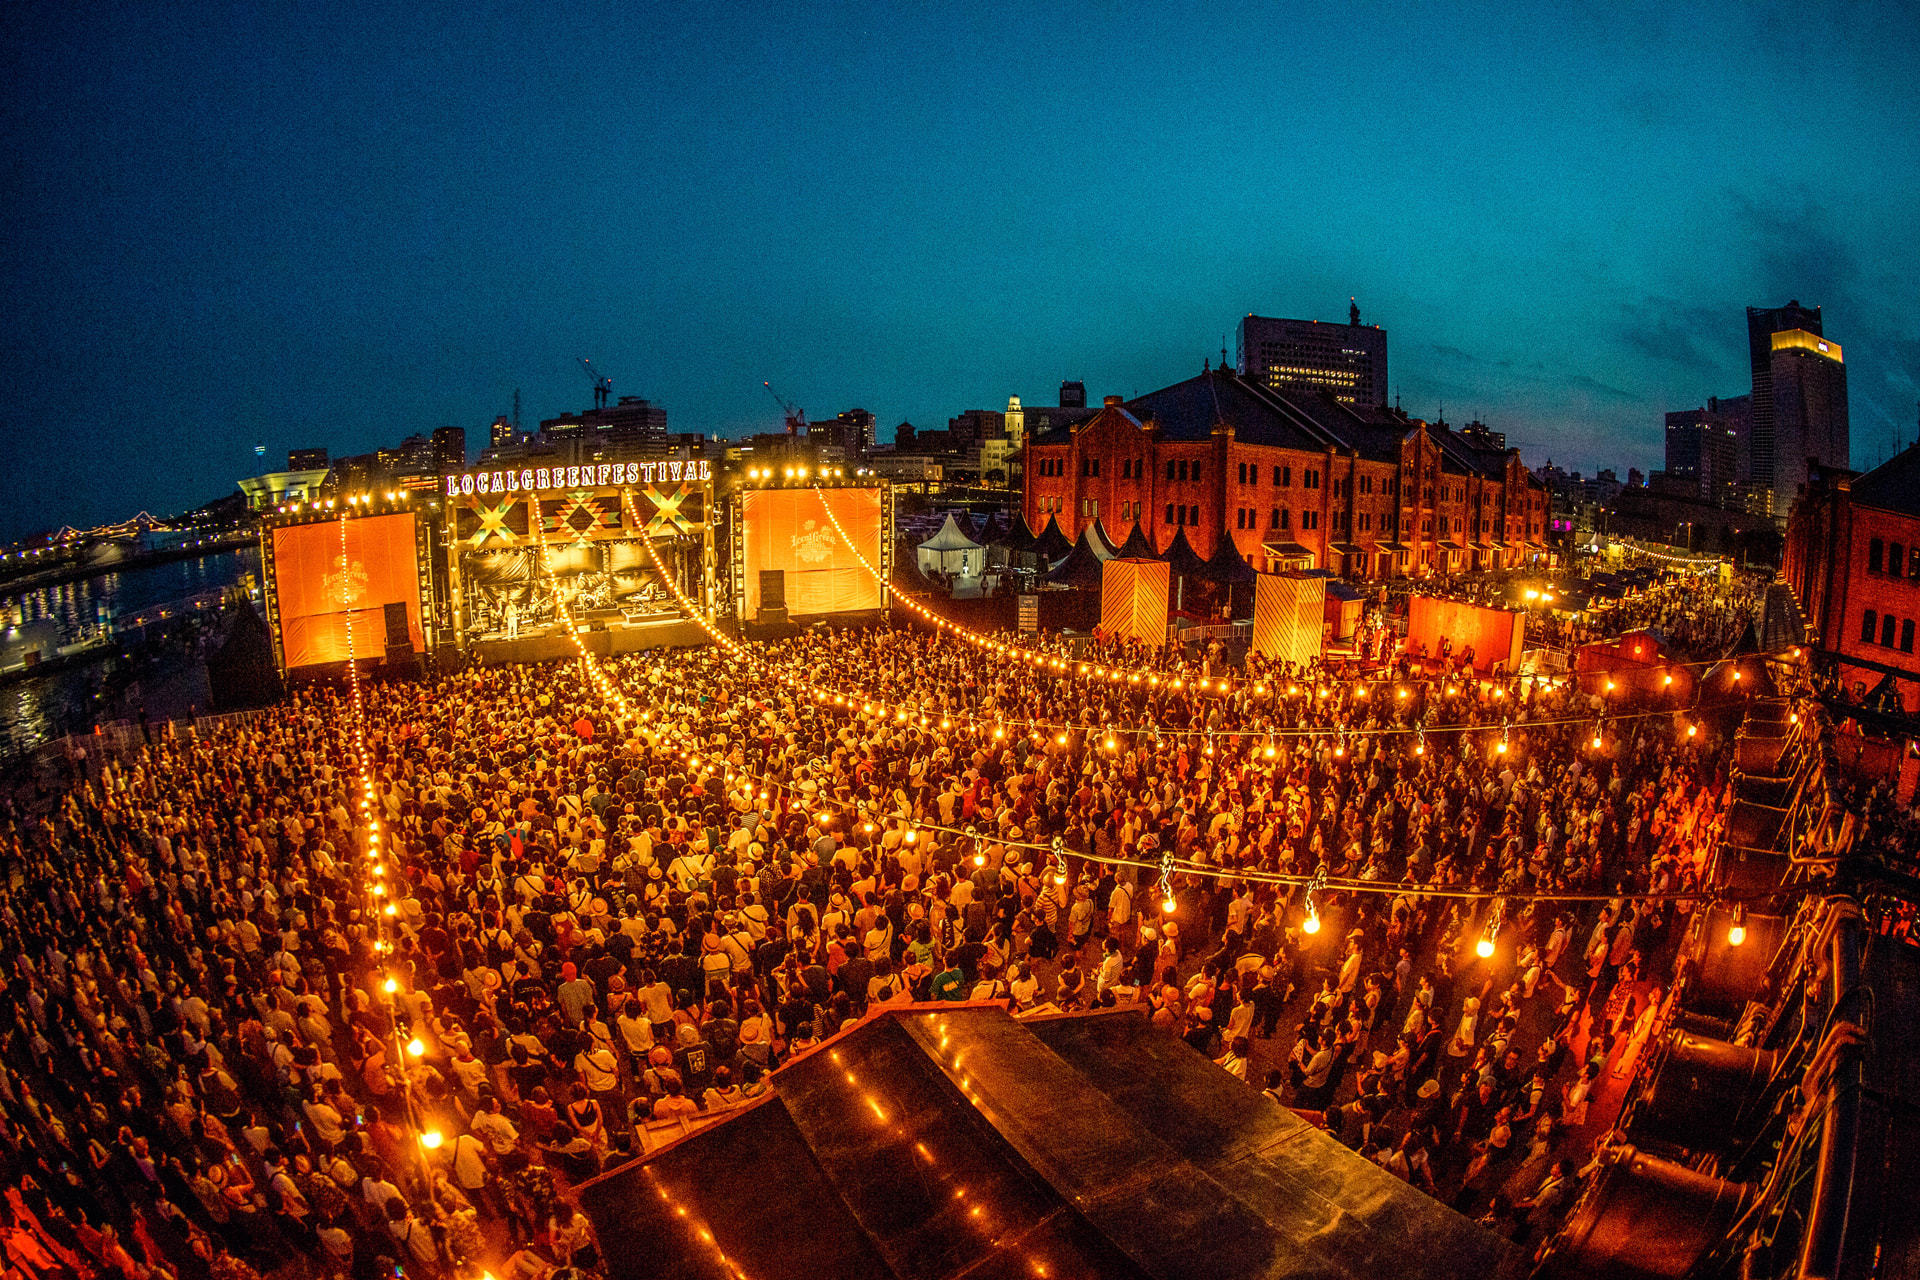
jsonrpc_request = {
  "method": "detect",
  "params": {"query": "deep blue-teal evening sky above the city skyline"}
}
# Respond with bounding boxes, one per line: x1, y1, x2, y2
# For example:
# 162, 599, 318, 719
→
0, 0, 1920, 532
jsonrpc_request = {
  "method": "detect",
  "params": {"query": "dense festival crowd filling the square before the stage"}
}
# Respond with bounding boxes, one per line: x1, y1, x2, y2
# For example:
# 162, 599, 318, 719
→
0, 571, 1766, 1280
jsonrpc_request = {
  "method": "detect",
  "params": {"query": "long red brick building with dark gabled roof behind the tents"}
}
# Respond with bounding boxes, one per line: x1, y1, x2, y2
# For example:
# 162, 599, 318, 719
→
1023, 368, 1548, 580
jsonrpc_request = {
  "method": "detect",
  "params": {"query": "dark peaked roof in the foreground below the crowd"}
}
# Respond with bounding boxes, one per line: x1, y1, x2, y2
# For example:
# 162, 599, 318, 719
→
582, 1006, 1521, 1280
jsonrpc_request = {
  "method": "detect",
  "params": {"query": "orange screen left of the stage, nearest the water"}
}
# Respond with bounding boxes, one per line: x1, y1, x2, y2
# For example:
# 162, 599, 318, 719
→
273, 510, 426, 670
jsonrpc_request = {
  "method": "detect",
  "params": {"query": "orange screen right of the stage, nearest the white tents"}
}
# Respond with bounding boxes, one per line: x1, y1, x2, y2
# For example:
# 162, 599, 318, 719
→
739, 489, 881, 618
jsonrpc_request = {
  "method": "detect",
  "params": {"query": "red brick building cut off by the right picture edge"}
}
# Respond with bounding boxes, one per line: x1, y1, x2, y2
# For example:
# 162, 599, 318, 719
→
1782, 445, 1920, 712
